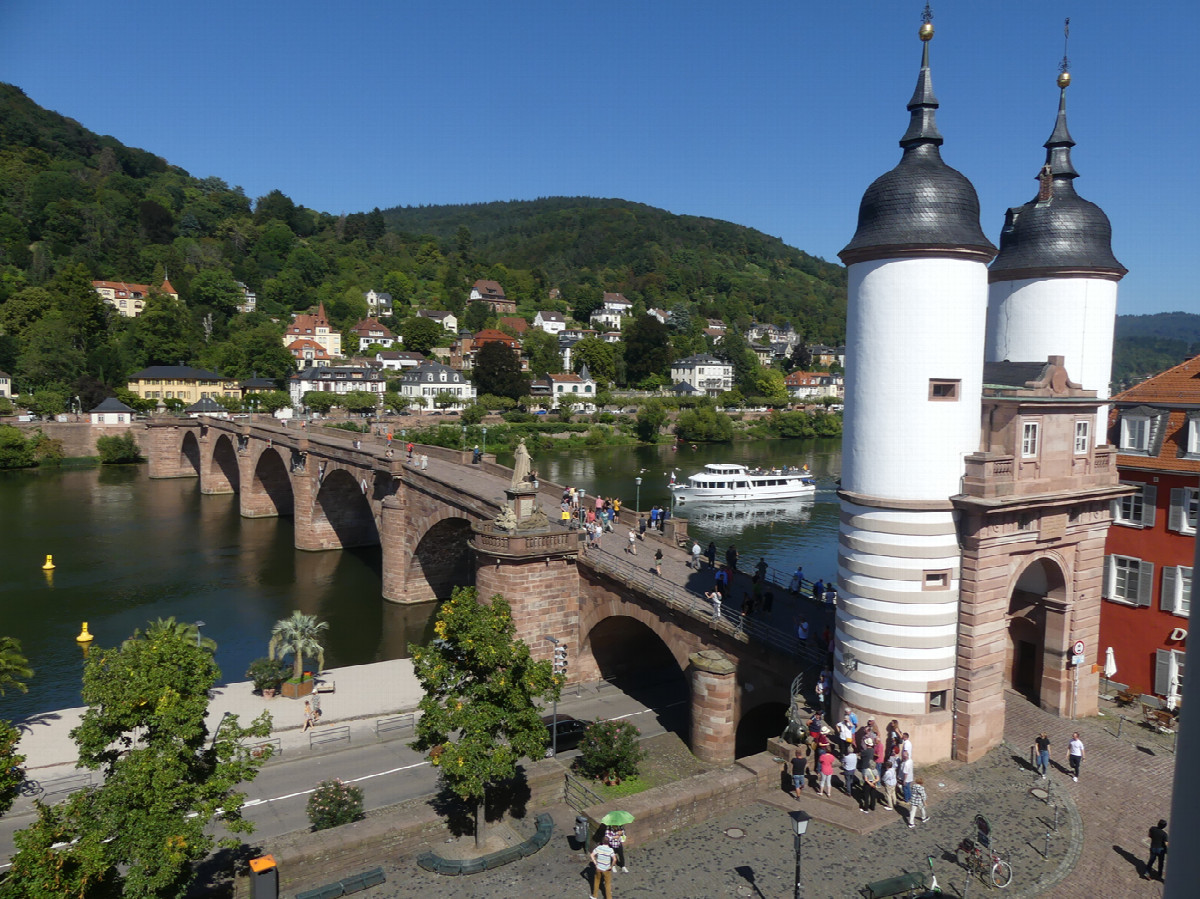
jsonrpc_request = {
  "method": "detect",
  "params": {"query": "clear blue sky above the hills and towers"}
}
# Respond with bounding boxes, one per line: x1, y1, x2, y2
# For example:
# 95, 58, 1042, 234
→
0, 0, 1200, 313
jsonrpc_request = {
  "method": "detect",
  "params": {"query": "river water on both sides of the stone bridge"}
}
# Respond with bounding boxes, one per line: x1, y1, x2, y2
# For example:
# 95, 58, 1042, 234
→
0, 439, 841, 720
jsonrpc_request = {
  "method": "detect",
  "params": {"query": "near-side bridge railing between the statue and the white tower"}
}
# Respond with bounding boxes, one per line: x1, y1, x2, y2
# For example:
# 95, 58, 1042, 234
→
583, 550, 823, 665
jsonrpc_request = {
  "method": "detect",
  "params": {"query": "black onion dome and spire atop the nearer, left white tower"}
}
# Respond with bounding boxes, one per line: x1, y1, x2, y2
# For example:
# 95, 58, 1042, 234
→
839, 33, 996, 265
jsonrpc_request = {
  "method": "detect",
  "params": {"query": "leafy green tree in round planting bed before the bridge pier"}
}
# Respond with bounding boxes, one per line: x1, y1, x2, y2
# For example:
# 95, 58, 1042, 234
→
408, 587, 562, 845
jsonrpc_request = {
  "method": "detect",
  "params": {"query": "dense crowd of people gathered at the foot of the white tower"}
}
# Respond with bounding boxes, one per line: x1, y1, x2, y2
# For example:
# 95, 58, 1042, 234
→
791, 709, 929, 827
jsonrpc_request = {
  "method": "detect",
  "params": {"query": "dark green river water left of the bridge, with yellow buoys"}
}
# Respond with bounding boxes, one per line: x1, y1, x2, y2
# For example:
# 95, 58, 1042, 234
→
0, 466, 434, 719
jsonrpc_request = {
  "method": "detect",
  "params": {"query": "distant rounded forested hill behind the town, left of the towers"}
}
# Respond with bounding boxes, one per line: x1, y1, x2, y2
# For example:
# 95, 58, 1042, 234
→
384, 197, 846, 342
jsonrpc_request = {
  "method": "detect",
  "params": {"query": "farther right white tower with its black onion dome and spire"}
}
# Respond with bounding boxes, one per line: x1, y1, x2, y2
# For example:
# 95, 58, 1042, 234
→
985, 69, 1126, 432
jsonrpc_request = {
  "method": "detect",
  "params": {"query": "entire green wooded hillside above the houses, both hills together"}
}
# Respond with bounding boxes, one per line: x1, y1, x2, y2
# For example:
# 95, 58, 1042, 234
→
0, 84, 845, 412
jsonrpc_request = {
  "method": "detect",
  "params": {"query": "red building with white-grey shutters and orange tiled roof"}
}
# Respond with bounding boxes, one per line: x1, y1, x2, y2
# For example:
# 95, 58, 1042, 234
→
1099, 356, 1200, 705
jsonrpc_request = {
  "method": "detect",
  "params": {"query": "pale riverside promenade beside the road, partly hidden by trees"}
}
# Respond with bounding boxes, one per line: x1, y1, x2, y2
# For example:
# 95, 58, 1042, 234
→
17, 659, 422, 781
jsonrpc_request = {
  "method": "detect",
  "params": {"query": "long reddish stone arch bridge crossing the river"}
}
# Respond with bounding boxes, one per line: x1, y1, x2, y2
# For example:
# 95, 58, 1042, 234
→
144, 419, 818, 763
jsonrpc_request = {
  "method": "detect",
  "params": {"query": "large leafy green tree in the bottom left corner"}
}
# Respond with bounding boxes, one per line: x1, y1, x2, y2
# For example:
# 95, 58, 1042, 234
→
6, 629, 271, 899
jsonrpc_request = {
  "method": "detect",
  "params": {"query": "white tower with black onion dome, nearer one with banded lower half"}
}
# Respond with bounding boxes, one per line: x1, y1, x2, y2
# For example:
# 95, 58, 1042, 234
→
834, 19, 996, 763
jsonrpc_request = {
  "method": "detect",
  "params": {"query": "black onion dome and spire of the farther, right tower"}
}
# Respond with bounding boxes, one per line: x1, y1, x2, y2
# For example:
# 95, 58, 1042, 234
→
988, 88, 1127, 281
